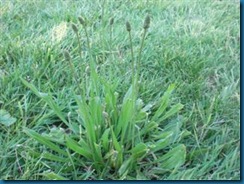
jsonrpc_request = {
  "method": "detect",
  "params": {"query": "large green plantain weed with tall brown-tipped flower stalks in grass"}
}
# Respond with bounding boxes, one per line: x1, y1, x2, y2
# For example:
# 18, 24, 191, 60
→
21, 16, 186, 179
